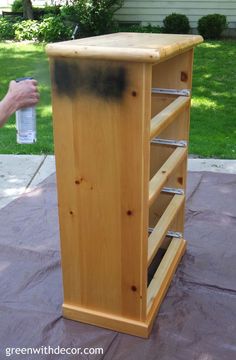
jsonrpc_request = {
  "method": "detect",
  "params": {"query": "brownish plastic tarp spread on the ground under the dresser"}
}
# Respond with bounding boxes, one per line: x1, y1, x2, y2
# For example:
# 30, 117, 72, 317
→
0, 173, 236, 360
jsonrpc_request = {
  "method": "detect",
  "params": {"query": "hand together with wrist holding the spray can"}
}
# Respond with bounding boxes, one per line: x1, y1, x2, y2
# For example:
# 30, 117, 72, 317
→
0, 80, 39, 127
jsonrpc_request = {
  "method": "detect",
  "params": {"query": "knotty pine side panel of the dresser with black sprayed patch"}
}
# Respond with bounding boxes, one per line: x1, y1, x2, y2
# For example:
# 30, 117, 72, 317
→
52, 59, 150, 319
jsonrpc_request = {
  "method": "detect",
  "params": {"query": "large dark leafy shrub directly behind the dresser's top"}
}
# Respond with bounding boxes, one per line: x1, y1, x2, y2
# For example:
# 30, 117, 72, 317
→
61, 0, 124, 36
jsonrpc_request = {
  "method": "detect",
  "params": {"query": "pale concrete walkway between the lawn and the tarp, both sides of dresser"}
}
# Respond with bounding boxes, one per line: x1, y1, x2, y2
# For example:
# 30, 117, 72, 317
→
0, 155, 236, 209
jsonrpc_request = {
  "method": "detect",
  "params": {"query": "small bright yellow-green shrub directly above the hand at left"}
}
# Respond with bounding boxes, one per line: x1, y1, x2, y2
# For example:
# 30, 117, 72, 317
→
14, 20, 40, 41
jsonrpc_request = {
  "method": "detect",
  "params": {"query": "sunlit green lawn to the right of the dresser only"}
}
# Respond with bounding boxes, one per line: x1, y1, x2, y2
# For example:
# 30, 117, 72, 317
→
190, 41, 236, 159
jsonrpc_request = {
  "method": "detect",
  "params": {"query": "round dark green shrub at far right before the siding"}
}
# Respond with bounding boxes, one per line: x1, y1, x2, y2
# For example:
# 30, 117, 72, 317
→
198, 14, 227, 39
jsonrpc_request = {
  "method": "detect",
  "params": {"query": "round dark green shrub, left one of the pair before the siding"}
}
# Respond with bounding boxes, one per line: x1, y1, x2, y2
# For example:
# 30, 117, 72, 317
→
163, 13, 190, 34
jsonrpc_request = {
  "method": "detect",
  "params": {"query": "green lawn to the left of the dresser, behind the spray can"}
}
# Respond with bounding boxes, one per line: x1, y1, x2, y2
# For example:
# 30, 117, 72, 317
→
0, 43, 53, 154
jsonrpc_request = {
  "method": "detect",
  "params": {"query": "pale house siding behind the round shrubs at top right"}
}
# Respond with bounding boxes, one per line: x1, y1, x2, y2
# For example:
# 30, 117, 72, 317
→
116, 0, 236, 28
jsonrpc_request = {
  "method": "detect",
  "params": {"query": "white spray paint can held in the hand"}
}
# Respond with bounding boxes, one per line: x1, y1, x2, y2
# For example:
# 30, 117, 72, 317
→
16, 77, 37, 144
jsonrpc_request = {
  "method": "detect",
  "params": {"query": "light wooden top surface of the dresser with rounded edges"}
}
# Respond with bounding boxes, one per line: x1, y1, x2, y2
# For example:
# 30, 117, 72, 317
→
46, 33, 203, 63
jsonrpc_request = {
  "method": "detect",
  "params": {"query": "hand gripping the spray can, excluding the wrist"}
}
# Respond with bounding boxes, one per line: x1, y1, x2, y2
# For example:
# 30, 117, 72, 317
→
6, 80, 39, 112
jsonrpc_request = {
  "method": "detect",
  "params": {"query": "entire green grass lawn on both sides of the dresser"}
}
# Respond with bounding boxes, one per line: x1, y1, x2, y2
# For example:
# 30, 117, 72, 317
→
0, 41, 236, 159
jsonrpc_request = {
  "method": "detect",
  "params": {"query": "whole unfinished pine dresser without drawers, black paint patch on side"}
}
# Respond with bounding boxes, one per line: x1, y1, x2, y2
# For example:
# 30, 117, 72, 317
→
46, 33, 202, 337
